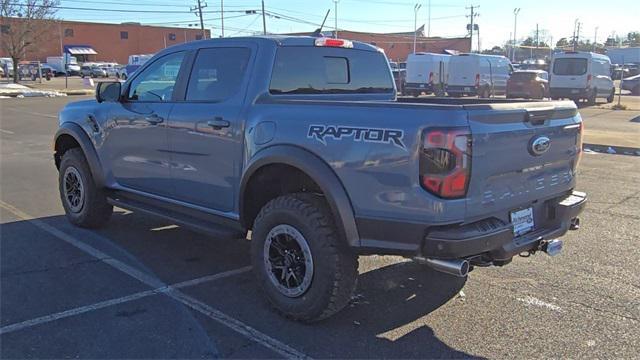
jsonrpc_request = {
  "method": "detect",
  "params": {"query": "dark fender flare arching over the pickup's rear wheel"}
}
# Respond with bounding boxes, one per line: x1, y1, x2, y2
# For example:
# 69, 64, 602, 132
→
238, 145, 360, 247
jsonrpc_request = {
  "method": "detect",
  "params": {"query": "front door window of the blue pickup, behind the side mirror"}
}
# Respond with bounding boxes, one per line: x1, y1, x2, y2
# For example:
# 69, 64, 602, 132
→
127, 52, 184, 102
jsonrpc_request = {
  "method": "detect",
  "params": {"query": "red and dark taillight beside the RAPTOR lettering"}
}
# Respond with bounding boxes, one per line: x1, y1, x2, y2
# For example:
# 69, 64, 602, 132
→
420, 128, 471, 199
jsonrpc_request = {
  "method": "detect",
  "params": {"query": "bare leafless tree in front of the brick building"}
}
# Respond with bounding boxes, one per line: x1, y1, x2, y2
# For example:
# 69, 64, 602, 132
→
0, 0, 60, 83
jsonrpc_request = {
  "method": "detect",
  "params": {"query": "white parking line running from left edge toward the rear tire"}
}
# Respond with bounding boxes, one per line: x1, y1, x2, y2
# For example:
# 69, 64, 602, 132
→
0, 266, 251, 335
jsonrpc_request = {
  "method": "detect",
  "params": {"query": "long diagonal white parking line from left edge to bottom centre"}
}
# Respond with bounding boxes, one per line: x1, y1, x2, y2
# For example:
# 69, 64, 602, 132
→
0, 200, 309, 359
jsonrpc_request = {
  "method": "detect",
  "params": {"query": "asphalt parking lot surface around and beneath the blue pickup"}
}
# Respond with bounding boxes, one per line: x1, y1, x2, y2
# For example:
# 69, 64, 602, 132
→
0, 97, 640, 358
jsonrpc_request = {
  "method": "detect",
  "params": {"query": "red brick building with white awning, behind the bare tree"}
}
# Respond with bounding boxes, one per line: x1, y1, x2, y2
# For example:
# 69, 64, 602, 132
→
0, 18, 211, 64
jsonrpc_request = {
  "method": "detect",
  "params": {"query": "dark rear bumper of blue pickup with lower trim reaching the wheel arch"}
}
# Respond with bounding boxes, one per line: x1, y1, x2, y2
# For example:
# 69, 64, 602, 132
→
357, 191, 587, 262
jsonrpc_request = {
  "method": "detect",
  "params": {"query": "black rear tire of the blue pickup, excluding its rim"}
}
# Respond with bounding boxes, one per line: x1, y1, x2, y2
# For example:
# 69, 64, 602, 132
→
251, 193, 358, 322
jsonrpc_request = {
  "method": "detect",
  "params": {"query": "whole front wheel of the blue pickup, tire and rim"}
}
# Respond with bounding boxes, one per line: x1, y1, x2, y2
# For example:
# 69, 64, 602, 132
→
58, 148, 113, 228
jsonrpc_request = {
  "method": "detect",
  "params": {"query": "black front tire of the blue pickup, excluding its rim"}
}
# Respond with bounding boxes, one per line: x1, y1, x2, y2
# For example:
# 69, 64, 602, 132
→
58, 148, 113, 228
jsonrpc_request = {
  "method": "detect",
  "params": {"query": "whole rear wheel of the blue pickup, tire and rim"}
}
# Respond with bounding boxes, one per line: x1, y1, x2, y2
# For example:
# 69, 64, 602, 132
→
251, 193, 358, 322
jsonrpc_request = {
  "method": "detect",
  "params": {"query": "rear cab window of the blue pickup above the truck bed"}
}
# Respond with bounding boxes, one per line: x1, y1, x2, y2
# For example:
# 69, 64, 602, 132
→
270, 46, 393, 94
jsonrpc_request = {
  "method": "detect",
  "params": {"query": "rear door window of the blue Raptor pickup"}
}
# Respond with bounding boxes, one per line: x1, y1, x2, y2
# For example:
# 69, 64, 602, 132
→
186, 48, 251, 102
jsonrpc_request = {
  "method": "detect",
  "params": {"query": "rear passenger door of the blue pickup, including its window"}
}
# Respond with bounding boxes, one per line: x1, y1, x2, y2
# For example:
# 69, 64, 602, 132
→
168, 45, 252, 212
